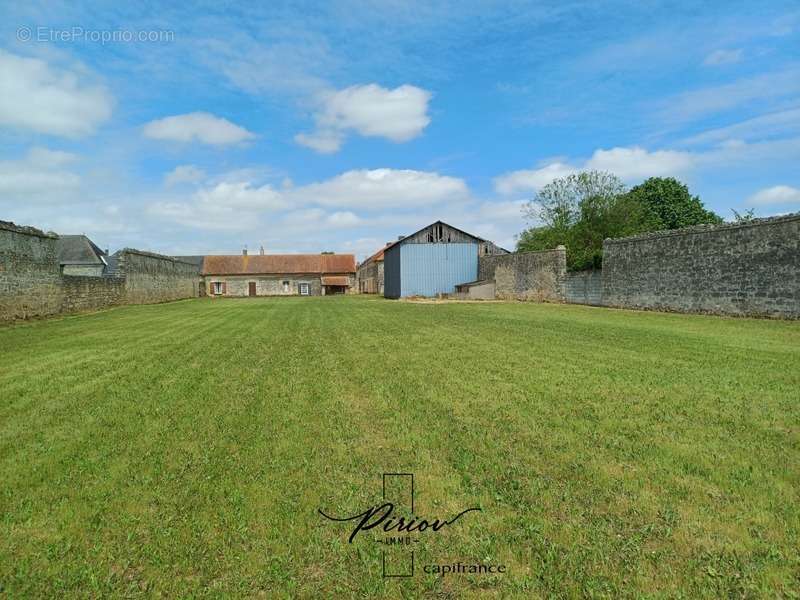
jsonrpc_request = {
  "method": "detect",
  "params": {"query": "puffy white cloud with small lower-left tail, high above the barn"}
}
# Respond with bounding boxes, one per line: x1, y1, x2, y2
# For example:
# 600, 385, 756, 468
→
295, 83, 431, 153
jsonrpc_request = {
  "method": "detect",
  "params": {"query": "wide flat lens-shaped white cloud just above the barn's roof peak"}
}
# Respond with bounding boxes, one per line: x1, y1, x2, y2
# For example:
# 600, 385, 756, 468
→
293, 169, 469, 209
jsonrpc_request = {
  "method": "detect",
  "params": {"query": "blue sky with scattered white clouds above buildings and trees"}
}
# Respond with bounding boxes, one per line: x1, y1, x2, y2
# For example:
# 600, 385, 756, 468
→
0, 0, 800, 258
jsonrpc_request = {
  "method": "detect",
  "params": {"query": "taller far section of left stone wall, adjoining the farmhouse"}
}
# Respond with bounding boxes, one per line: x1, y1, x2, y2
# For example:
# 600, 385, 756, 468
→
117, 248, 200, 304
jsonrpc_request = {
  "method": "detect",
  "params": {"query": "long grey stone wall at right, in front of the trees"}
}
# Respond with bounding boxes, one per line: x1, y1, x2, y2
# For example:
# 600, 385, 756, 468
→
603, 214, 800, 318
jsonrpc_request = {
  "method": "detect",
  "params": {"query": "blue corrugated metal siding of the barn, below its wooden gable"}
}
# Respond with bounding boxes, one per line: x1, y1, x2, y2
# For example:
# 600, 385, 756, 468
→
398, 243, 478, 297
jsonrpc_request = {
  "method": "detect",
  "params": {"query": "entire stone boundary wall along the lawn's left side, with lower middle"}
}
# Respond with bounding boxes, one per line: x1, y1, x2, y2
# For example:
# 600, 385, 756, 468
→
0, 221, 200, 322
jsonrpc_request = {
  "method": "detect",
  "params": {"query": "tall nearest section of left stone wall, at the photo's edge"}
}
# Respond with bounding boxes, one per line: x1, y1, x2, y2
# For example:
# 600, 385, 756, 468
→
0, 221, 62, 321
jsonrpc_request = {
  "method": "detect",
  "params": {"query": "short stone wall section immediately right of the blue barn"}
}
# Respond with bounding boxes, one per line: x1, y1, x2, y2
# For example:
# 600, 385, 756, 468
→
478, 246, 567, 302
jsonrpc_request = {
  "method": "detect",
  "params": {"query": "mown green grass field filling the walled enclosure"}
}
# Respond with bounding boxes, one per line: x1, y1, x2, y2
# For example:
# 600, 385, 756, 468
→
0, 297, 800, 598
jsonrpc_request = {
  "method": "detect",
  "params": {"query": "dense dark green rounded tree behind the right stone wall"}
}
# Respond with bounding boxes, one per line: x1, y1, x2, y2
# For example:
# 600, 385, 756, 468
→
628, 177, 722, 231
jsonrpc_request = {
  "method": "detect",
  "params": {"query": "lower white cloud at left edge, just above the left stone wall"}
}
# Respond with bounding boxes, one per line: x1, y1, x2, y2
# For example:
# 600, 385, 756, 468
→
0, 147, 81, 202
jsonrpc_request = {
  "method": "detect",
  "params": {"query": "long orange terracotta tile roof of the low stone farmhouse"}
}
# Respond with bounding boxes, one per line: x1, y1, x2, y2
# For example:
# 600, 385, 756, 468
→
202, 254, 356, 275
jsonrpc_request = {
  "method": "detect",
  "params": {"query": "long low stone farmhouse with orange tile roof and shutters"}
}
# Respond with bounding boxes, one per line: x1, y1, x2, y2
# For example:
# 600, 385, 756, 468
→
200, 252, 356, 296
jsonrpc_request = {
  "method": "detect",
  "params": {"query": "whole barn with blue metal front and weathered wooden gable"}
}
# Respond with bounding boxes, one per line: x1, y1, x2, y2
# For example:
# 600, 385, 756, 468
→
383, 221, 505, 298
